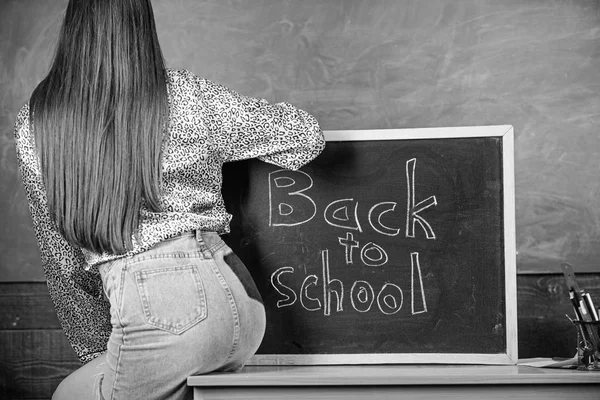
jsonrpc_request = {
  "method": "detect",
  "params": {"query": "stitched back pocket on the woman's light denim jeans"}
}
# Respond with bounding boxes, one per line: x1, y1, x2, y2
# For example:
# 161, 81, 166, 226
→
134, 264, 207, 334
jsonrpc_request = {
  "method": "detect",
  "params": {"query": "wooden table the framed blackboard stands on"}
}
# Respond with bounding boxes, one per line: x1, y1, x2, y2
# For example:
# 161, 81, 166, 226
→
188, 365, 600, 400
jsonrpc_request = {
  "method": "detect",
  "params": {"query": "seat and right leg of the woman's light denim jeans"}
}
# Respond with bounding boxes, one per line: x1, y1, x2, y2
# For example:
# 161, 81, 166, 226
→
96, 232, 265, 400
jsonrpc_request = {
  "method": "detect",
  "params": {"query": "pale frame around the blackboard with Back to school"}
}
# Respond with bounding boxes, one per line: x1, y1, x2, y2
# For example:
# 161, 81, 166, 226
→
248, 125, 518, 365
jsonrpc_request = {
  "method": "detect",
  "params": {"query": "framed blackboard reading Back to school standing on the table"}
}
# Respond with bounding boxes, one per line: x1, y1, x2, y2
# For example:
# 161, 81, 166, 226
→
224, 126, 516, 364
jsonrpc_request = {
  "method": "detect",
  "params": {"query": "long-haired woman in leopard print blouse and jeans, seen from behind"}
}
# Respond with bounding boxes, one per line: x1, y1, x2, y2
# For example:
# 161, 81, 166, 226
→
15, 0, 324, 400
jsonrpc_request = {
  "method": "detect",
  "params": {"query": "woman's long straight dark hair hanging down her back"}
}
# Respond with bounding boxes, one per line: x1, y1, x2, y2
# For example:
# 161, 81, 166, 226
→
30, 0, 168, 254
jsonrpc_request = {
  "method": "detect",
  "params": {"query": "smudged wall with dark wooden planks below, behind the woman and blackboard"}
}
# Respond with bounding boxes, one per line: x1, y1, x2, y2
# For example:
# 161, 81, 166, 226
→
0, 0, 600, 398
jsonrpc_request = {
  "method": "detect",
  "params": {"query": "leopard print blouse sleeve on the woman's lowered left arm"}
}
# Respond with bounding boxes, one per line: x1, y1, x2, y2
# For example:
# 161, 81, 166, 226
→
15, 105, 111, 362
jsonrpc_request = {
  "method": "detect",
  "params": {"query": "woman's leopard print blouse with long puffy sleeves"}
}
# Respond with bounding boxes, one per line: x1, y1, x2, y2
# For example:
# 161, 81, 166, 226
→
15, 69, 325, 362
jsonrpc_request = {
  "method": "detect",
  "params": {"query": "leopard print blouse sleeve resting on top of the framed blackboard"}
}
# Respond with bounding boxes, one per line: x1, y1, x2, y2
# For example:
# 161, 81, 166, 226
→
198, 79, 325, 170
